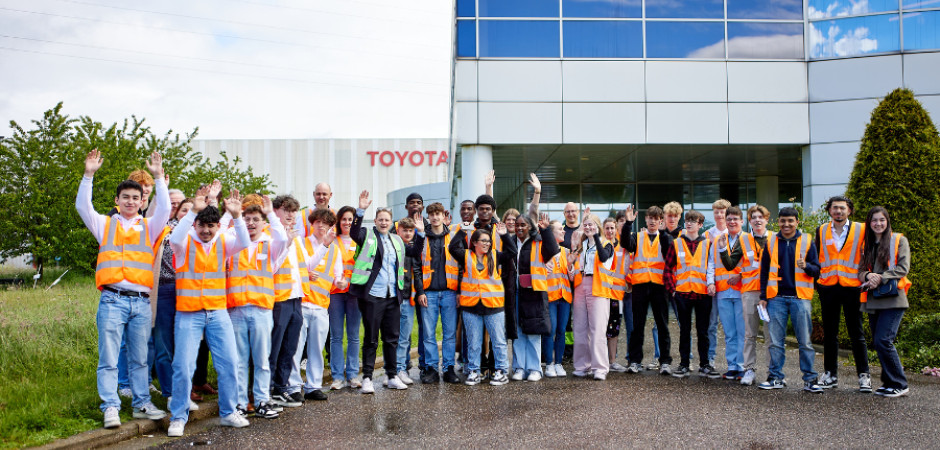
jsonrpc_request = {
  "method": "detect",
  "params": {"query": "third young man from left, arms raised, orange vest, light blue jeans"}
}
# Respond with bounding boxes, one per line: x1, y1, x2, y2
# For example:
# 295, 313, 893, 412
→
225, 196, 290, 419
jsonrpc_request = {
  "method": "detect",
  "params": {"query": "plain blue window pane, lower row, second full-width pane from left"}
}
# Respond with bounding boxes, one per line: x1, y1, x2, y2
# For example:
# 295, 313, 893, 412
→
564, 20, 643, 58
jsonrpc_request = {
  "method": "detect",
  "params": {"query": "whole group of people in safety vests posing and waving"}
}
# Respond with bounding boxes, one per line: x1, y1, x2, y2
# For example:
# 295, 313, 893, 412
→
76, 150, 910, 436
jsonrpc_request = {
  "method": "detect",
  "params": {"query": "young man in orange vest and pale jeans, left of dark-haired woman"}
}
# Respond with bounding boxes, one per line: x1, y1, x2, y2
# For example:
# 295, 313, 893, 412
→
290, 209, 349, 400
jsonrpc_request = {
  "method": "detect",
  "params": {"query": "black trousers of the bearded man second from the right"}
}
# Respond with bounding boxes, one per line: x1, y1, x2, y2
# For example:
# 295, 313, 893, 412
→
819, 286, 869, 375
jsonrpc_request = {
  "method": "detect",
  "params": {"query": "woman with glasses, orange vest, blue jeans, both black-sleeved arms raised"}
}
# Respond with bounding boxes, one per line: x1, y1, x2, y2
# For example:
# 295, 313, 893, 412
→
447, 222, 516, 386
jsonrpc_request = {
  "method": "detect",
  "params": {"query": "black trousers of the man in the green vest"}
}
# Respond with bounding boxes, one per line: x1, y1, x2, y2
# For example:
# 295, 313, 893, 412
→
359, 294, 401, 379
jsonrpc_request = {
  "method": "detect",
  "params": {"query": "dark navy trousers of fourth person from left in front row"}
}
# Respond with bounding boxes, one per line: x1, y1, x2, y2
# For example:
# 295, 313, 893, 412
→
268, 297, 304, 395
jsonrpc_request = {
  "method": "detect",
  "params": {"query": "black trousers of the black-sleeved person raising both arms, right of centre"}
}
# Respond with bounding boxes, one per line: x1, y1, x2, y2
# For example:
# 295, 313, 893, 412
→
627, 283, 672, 364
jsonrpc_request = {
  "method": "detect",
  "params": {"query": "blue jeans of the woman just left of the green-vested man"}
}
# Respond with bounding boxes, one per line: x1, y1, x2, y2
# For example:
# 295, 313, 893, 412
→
328, 292, 362, 380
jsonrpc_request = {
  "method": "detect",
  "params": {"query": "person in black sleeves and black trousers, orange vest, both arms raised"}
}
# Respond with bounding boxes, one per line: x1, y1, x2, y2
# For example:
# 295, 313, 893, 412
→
620, 205, 673, 375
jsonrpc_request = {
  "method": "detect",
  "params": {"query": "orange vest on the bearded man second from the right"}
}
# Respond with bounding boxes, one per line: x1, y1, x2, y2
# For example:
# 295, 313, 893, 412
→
817, 222, 865, 287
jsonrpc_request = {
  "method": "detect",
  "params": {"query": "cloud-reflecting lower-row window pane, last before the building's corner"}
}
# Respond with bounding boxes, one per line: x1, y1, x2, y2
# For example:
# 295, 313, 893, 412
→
728, 22, 803, 59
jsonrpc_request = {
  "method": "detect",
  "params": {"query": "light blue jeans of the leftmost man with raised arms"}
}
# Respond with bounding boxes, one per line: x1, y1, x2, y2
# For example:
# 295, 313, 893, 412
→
95, 291, 151, 411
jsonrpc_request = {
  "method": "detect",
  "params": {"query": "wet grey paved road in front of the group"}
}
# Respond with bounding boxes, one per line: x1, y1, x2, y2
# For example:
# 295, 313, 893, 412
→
115, 327, 940, 449
